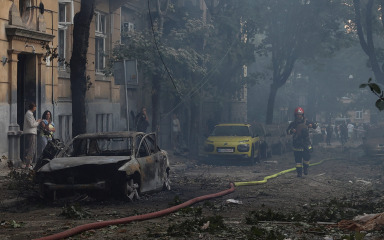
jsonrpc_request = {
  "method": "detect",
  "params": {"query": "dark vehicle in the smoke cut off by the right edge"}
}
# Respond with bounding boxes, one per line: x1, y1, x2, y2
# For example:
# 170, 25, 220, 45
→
363, 125, 384, 157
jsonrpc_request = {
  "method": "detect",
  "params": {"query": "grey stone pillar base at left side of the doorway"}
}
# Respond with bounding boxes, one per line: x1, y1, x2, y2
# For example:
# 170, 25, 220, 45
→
8, 123, 23, 167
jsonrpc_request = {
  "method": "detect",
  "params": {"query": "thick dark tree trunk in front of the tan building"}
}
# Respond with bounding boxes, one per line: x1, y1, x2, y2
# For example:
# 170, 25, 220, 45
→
70, 0, 95, 137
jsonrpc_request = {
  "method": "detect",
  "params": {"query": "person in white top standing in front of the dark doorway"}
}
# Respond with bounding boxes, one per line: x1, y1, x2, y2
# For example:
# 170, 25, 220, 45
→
22, 103, 41, 169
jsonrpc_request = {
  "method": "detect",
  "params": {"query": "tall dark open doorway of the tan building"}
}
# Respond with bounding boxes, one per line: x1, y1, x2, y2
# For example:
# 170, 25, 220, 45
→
17, 54, 39, 159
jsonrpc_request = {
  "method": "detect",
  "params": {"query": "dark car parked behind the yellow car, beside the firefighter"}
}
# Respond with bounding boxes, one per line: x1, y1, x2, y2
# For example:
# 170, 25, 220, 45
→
265, 124, 292, 155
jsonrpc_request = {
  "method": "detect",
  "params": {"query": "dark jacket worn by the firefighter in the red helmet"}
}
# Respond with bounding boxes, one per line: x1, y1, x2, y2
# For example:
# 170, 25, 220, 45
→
287, 118, 317, 151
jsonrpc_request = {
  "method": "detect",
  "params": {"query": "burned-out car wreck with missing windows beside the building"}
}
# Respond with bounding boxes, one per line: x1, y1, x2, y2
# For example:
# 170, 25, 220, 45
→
36, 132, 170, 200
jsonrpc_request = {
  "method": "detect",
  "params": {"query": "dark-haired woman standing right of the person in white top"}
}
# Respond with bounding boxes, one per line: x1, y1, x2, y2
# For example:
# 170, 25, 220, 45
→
37, 110, 56, 157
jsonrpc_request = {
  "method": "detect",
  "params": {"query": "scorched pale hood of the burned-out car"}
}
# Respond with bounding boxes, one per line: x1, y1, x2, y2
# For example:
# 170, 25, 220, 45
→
38, 156, 131, 172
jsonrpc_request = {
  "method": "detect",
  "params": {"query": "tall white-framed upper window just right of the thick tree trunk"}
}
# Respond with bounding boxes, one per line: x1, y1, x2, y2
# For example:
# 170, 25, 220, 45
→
95, 12, 106, 72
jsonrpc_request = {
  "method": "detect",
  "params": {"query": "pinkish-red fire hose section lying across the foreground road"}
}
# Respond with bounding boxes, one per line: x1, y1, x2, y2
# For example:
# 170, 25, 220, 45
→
34, 183, 235, 240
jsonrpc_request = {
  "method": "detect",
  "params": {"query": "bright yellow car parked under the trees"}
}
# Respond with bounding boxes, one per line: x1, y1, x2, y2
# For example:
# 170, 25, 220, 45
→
204, 123, 260, 164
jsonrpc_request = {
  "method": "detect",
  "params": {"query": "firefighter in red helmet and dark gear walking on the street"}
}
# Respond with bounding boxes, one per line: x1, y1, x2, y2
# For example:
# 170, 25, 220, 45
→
287, 107, 317, 177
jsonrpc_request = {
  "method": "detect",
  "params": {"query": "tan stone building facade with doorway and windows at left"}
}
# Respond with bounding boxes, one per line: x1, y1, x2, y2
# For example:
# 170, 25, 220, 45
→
0, 0, 126, 165
